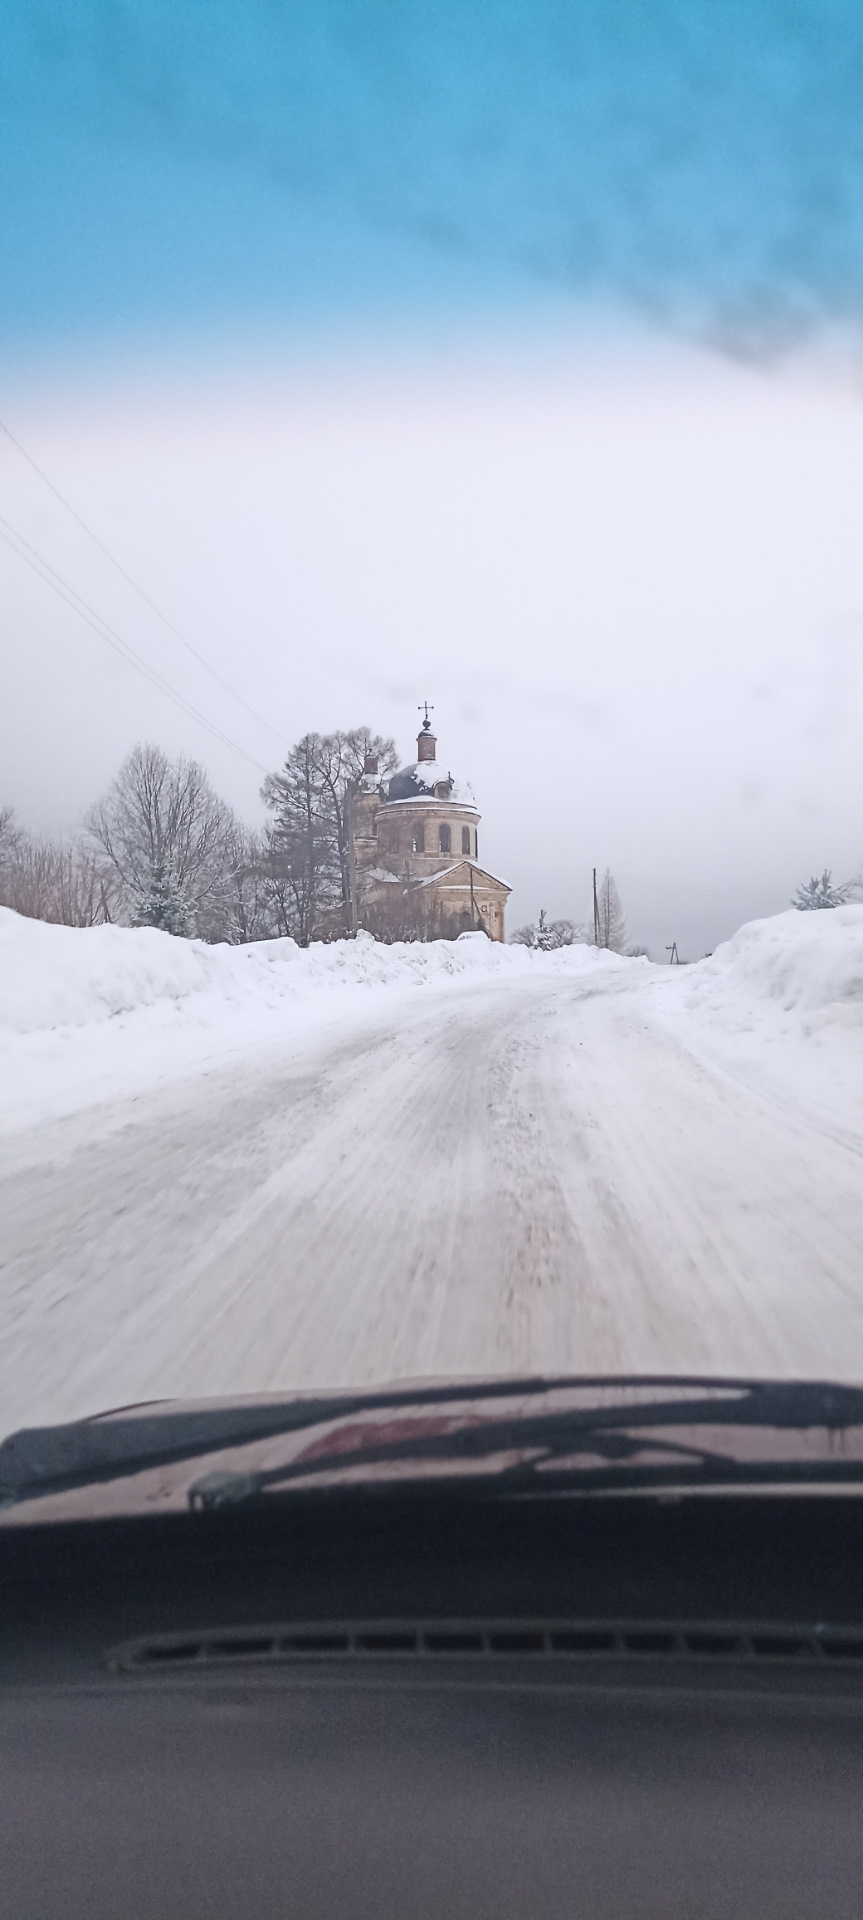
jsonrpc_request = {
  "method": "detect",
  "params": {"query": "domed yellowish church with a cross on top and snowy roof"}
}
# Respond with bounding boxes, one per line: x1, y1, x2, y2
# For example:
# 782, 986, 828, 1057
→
352, 714, 511, 941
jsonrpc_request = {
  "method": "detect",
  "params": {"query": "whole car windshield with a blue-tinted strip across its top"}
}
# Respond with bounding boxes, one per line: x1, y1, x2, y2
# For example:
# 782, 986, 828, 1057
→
0, 0, 863, 1443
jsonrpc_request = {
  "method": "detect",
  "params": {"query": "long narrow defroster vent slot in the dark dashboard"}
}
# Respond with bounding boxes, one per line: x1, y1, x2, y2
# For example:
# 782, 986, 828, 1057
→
108, 1620, 863, 1674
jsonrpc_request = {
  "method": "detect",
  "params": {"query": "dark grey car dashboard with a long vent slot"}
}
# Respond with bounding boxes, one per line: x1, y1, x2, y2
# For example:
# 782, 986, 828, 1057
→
0, 1488, 863, 1920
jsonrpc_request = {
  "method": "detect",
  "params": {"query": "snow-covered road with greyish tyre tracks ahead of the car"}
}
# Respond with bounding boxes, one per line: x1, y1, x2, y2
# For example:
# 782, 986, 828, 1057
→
0, 968, 863, 1430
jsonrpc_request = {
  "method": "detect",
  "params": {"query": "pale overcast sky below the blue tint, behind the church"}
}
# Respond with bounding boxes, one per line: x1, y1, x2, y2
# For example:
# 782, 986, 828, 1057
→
0, 338, 863, 956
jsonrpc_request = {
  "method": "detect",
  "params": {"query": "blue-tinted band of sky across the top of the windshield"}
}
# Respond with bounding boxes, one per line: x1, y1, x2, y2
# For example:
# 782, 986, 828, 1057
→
0, 0, 863, 353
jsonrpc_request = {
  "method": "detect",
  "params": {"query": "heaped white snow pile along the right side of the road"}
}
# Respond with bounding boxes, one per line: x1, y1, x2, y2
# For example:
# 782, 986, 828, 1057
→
684, 906, 863, 1035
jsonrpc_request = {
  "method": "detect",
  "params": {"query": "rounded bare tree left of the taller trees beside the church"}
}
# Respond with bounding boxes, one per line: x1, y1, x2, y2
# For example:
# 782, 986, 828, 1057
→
86, 745, 242, 941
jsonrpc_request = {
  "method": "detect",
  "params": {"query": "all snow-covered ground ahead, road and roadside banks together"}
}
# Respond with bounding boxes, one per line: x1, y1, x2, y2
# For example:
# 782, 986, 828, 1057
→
0, 906, 863, 1432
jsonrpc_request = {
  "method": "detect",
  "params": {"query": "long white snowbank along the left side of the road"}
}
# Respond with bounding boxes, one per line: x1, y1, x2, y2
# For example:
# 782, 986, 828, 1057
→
0, 908, 636, 1139
